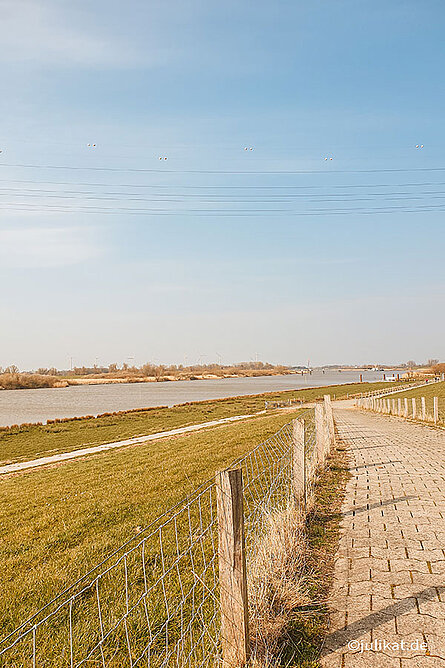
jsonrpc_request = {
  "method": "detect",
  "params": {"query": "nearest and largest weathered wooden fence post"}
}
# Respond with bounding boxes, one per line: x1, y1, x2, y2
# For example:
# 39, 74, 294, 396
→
216, 469, 250, 668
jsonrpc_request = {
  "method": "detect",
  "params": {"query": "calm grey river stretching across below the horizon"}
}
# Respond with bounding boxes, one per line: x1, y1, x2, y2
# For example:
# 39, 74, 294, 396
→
0, 370, 383, 427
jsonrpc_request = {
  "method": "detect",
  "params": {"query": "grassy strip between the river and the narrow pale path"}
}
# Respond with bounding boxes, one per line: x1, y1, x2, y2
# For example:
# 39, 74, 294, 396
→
0, 383, 396, 465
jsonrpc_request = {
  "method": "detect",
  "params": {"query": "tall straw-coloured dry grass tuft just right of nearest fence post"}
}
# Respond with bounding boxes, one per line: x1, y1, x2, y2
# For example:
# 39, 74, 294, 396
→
248, 502, 309, 668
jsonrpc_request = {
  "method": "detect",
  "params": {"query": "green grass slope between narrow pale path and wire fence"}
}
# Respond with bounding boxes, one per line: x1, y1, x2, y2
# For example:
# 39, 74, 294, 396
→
0, 412, 294, 637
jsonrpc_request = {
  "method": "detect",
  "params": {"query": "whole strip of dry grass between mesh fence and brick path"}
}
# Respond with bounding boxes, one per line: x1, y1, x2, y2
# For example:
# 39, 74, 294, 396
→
245, 444, 349, 668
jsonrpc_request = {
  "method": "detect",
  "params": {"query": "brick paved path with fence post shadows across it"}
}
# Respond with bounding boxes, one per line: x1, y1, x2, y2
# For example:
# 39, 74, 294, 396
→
322, 409, 445, 668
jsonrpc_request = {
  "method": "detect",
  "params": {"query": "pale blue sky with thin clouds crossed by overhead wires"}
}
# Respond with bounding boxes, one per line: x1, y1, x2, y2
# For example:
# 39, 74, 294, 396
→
0, 0, 445, 369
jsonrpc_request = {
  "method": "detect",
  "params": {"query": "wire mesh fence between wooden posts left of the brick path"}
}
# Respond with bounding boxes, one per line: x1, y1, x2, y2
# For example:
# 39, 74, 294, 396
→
0, 410, 330, 668
